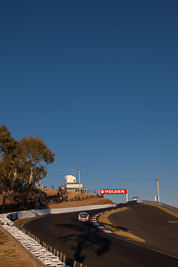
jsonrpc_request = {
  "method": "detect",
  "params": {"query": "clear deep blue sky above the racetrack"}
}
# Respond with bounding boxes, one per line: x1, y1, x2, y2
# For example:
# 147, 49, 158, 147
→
0, 0, 178, 206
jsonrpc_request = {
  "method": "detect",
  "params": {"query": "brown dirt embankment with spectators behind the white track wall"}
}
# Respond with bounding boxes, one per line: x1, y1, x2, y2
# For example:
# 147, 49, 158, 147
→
0, 189, 112, 215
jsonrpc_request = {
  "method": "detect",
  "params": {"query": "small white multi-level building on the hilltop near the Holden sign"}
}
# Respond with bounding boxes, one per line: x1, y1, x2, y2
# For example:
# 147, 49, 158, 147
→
65, 175, 88, 193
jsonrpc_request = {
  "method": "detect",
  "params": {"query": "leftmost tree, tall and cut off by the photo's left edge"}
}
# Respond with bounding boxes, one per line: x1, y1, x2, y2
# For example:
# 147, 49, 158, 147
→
0, 125, 21, 212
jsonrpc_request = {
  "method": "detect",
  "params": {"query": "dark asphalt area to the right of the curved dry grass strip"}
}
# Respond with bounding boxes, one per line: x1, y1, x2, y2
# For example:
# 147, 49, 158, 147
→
108, 204, 178, 257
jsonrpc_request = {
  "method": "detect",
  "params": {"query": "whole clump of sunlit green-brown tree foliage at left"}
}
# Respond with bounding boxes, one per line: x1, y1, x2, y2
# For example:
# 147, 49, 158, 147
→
0, 125, 55, 211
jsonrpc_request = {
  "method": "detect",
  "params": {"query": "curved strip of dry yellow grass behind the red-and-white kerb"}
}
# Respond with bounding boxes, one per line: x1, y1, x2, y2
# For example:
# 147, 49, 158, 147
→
99, 208, 145, 242
